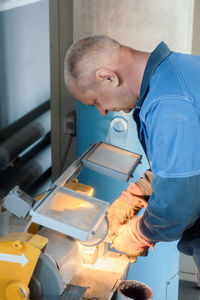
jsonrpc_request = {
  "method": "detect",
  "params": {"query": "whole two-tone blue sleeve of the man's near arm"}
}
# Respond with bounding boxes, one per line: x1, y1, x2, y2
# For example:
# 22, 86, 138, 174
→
139, 99, 200, 242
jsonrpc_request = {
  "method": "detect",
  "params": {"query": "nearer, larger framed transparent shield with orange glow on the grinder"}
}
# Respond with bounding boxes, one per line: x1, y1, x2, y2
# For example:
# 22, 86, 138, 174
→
30, 187, 109, 241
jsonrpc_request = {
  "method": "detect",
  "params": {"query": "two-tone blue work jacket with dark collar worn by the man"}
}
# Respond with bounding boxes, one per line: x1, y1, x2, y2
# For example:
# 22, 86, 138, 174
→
133, 42, 200, 243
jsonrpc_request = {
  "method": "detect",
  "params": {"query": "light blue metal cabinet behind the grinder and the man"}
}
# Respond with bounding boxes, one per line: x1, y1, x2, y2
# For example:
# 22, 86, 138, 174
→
77, 103, 179, 300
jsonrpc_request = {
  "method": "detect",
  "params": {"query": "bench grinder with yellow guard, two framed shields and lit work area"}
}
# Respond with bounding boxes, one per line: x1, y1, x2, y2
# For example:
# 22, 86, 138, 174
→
0, 142, 141, 300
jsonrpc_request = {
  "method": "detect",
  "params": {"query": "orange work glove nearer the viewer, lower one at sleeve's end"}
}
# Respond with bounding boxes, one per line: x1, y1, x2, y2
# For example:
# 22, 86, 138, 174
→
111, 216, 154, 258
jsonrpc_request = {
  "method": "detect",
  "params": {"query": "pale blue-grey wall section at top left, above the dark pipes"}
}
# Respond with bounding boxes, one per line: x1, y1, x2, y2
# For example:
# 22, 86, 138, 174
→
0, 0, 50, 129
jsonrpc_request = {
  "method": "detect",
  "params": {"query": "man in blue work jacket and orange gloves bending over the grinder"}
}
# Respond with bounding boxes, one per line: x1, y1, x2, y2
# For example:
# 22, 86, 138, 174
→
65, 36, 200, 284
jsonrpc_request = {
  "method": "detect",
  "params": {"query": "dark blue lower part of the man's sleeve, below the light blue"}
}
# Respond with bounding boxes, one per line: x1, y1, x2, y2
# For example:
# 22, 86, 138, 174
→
140, 175, 200, 242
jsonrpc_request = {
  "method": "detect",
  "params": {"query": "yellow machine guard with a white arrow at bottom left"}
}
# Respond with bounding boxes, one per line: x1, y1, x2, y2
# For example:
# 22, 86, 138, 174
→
0, 232, 48, 300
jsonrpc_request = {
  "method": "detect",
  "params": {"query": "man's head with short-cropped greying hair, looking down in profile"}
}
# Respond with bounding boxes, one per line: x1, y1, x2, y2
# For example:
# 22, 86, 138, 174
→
64, 35, 147, 114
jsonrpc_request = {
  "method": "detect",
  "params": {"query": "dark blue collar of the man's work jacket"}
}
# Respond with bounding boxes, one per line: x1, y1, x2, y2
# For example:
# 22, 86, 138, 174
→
136, 42, 171, 108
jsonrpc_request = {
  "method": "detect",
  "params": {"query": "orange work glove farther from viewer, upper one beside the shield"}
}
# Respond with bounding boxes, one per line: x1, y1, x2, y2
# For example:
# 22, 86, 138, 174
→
105, 183, 147, 242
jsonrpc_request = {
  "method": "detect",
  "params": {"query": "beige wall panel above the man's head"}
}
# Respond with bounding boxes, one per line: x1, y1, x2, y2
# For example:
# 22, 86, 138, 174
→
74, 0, 195, 53
